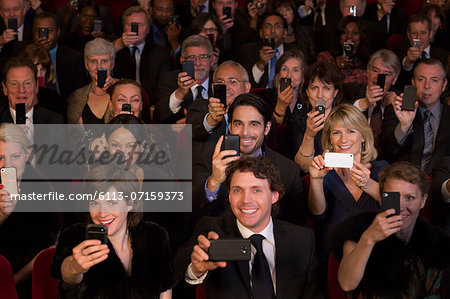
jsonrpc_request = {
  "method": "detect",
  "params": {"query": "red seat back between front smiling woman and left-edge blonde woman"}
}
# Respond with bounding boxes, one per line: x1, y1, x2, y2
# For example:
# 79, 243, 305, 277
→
31, 247, 58, 299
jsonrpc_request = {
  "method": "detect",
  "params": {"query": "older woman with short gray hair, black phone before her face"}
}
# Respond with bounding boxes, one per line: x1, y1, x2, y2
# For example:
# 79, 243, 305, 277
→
67, 38, 117, 124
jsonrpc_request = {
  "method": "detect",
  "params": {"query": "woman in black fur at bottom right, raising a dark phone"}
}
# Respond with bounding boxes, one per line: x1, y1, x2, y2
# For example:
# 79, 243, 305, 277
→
331, 162, 450, 298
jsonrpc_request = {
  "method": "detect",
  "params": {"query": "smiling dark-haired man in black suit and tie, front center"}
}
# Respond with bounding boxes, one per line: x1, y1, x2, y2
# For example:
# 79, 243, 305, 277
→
175, 157, 322, 299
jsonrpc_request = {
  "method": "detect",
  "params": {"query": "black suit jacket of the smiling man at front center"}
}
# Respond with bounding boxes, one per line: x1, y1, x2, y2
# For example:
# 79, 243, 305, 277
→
175, 215, 322, 299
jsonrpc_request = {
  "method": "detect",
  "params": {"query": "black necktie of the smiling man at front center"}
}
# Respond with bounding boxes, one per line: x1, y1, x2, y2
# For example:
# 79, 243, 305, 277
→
249, 234, 275, 299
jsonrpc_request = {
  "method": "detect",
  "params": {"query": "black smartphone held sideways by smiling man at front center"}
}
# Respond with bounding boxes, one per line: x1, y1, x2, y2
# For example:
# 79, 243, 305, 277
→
208, 239, 251, 262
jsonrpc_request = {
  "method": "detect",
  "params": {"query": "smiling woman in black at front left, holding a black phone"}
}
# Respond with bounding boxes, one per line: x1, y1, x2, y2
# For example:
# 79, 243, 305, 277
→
51, 165, 174, 298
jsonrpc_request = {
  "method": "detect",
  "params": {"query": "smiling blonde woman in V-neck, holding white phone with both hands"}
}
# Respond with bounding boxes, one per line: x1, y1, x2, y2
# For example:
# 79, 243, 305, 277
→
308, 104, 388, 264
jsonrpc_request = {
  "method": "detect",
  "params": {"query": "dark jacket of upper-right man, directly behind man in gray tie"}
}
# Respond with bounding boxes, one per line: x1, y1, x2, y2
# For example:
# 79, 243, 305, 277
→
394, 40, 450, 90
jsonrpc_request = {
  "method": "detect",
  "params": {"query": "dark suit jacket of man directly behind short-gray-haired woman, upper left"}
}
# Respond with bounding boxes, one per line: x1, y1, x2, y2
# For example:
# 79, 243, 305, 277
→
113, 40, 170, 105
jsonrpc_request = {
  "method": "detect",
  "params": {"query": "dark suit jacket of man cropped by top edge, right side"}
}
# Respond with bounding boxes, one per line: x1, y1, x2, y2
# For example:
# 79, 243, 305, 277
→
363, 3, 408, 39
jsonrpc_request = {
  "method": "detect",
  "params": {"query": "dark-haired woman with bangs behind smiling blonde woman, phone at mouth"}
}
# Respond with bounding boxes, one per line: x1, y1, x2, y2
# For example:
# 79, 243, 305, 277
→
287, 62, 342, 173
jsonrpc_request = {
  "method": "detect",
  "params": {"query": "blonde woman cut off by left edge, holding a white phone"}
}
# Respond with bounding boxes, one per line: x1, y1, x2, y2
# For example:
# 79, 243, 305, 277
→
0, 123, 62, 298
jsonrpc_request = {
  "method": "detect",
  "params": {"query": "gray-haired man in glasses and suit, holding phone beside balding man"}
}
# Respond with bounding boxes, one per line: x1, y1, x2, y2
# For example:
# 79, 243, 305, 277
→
155, 35, 214, 123
